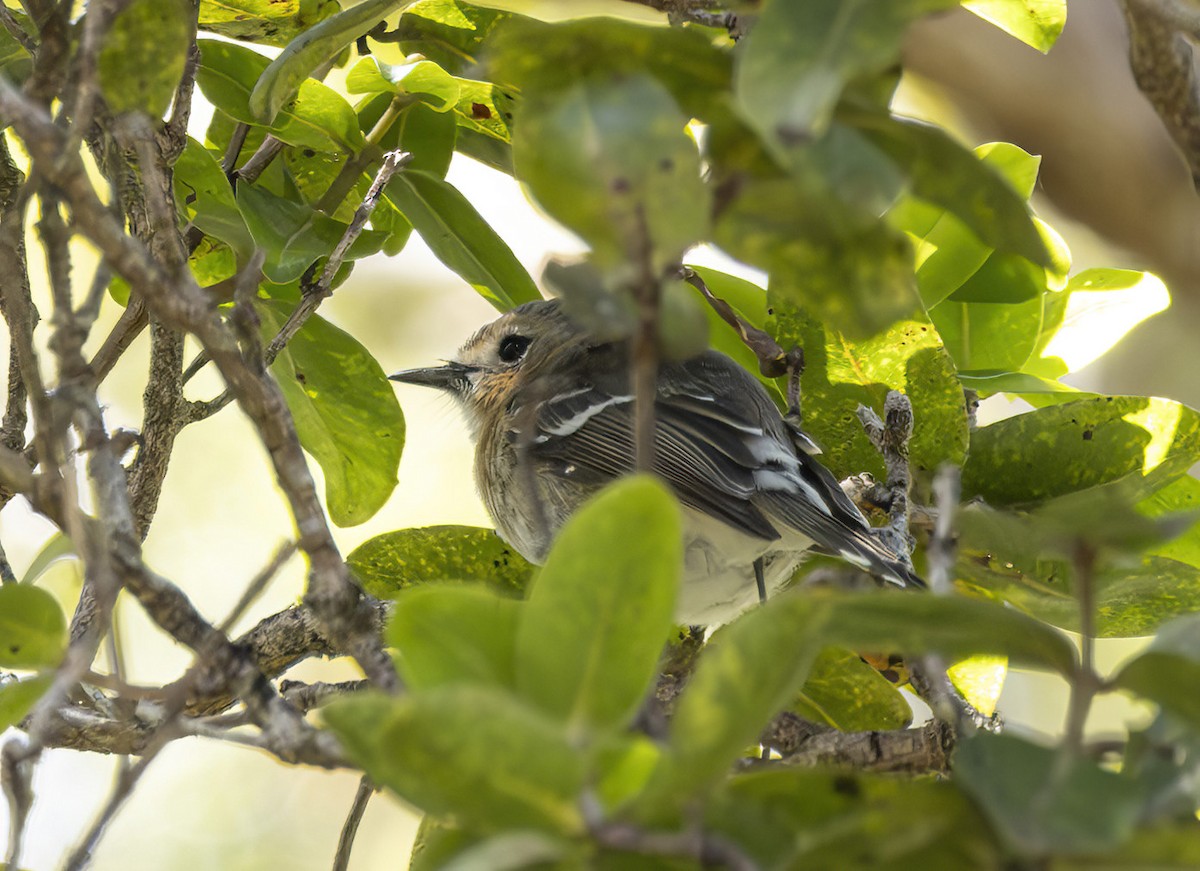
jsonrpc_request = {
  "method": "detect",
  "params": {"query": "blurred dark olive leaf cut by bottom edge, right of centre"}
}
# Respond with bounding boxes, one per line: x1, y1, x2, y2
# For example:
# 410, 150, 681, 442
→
704, 768, 1004, 871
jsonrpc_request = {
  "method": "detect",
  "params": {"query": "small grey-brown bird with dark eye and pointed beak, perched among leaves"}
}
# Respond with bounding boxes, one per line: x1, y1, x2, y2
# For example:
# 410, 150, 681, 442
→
391, 301, 924, 625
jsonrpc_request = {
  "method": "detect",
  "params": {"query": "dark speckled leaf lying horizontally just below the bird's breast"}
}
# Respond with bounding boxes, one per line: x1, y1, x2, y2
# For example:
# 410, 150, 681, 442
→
346, 527, 533, 599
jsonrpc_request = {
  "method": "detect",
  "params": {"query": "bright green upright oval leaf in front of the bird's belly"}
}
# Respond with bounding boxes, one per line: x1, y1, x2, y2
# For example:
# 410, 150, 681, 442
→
516, 476, 683, 734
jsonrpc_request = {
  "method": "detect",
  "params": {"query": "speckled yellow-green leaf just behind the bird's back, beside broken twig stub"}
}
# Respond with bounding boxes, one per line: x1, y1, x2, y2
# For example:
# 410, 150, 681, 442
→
772, 303, 967, 480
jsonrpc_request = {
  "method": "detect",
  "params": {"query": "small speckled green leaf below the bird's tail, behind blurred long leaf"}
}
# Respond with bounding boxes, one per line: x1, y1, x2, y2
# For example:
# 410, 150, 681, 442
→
791, 647, 912, 732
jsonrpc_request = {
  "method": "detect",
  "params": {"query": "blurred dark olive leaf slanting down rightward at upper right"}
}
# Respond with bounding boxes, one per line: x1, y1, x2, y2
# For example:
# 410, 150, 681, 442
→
859, 113, 1049, 265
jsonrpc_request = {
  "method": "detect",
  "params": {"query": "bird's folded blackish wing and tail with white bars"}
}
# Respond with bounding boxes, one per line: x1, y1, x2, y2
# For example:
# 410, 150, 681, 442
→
516, 353, 914, 585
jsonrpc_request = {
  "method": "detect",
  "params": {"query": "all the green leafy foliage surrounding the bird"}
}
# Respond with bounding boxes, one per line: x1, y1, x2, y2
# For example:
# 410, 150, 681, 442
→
0, 0, 1200, 869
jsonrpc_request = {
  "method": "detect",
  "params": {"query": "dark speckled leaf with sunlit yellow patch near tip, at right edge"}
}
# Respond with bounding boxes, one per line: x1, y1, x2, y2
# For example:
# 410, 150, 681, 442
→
962, 396, 1200, 505
